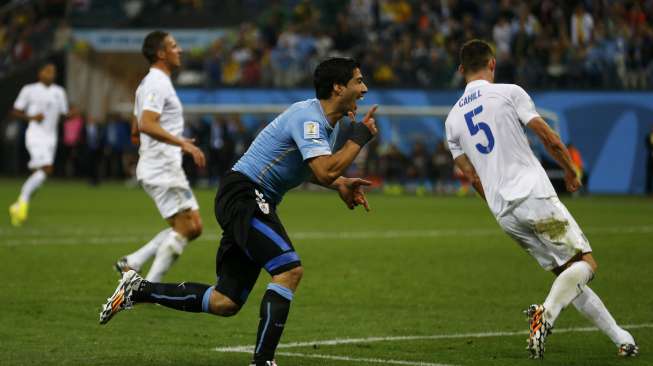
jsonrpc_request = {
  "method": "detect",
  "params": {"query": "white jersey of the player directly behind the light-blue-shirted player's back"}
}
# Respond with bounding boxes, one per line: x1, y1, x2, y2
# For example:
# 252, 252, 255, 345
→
134, 68, 186, 186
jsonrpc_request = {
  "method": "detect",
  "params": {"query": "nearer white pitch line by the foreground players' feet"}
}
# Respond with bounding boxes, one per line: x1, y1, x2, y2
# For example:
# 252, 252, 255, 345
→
214, 323, 653, 352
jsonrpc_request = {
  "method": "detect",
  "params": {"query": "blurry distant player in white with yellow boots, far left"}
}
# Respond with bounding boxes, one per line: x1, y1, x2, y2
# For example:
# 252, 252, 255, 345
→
9, 63, 68, 226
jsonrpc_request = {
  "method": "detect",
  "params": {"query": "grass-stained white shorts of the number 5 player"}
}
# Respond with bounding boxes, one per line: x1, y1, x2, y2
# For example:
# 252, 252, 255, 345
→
497, 197, 592, 271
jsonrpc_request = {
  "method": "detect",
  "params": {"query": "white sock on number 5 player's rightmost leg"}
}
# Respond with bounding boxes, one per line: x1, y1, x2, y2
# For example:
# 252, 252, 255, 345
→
572, 286, 635, 347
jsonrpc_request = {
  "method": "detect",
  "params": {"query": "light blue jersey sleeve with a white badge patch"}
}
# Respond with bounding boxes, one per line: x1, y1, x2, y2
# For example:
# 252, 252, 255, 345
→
289, 121, 331, 160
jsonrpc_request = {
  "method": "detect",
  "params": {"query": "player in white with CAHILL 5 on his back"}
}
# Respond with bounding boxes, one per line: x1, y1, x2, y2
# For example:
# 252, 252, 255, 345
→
445, 40, 638, 358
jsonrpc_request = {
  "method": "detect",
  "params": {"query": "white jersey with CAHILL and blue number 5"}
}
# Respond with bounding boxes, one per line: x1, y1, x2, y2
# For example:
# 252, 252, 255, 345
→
445, 80, 556, 217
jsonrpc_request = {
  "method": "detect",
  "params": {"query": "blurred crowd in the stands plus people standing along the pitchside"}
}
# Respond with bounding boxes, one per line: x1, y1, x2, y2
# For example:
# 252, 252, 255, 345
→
0, 0, 653, 192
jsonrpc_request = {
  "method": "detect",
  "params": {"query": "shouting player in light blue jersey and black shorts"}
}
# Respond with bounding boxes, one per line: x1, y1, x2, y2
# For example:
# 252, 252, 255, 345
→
100, 58, 378, 366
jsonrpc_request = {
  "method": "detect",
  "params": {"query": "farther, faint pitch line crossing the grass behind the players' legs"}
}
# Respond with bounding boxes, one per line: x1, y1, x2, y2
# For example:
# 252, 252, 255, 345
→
0, 226, 653, 246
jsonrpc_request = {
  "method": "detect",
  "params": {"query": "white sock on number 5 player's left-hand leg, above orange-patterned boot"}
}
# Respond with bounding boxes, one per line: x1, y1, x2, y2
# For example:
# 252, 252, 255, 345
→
543, 261, 594, 325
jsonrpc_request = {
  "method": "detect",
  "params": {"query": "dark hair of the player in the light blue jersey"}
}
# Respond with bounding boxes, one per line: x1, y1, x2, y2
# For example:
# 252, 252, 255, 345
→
313, 57, 360, 99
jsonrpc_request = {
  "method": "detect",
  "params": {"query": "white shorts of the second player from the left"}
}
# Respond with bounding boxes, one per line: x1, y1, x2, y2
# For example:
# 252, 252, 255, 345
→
141, 183, 200, 219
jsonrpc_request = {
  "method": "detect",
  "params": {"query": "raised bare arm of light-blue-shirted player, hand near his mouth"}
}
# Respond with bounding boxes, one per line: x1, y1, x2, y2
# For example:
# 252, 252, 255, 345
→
308, 105, 379, 188
